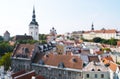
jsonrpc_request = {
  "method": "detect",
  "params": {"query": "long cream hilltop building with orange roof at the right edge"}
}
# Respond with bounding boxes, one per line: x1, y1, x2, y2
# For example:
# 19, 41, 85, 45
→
82, 29, 120, 40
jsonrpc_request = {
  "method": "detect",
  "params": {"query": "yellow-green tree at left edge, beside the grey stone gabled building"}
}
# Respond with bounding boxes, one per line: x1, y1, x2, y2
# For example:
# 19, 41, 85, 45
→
0, 53, 11, 70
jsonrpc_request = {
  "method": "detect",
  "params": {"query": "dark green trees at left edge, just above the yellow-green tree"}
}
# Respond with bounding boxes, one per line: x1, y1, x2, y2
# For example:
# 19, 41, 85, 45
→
0, 41, 14, 56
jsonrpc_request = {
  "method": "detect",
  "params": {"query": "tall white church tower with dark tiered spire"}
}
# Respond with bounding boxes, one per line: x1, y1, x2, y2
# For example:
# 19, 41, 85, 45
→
29, 7, 39, 40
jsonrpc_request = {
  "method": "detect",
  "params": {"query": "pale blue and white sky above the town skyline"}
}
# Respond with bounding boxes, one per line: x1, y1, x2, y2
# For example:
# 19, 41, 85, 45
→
0, 0, 120, 36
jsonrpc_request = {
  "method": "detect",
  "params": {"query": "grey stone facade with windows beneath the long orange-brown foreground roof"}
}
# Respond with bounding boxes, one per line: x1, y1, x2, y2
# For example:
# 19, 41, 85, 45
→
32, 64, 82, 79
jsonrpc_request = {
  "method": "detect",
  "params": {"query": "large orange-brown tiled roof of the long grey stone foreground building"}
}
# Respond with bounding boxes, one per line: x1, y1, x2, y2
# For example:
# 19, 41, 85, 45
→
42, 54, 83, 69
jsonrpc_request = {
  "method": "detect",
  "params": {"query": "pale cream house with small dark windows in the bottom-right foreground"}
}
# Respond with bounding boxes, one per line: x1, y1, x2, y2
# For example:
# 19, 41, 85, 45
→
83, 62, 111, 79
